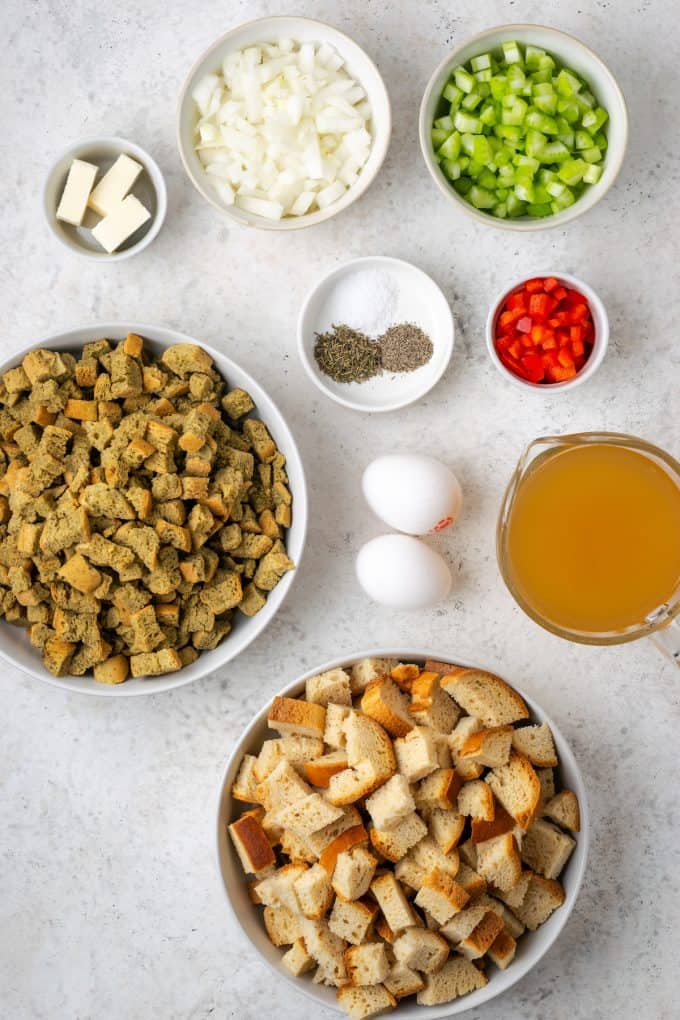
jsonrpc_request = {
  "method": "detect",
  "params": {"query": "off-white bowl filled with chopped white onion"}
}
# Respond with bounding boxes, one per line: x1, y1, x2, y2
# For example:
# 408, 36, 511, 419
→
177, 17, 391, 230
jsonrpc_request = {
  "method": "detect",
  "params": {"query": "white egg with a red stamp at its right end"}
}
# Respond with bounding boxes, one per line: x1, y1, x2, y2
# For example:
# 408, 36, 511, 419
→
362, 453, 463, 534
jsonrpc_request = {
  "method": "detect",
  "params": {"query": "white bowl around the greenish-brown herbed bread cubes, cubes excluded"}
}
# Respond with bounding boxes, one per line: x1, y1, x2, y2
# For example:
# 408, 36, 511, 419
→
0, 321, 308, 698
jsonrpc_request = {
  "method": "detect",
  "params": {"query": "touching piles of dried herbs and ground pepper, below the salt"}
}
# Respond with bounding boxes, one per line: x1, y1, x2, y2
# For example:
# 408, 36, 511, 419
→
314, 322, 434, 383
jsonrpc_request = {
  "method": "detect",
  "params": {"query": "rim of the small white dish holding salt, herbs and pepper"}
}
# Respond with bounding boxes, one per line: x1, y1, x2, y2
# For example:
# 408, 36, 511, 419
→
298, 255, 456, 414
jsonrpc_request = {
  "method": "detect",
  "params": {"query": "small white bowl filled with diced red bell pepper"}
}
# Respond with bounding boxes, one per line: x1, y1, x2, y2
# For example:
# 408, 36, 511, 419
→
486, 272, 609, 393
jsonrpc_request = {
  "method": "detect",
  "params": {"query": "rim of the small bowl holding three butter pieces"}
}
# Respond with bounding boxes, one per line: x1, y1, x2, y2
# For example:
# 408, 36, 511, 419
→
42, 135, 167, 262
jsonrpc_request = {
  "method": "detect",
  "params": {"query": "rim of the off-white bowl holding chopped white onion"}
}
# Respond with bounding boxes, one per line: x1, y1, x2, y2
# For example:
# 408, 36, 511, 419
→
175, 14, 391, 231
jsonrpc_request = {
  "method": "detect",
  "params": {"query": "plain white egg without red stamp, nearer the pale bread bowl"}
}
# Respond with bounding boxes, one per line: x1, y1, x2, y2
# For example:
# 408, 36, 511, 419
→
357, 534, 451, 609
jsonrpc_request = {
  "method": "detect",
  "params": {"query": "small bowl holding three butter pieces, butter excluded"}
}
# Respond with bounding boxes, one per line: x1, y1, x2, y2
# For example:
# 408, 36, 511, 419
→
43, 138, 167, 262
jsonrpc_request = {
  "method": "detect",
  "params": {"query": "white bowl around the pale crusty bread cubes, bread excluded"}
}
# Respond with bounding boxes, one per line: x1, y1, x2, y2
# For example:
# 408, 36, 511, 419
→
217, 649, 590, 1020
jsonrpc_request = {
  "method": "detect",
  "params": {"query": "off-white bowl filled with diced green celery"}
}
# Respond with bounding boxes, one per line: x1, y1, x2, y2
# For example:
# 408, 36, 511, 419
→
420, 24, 628, 231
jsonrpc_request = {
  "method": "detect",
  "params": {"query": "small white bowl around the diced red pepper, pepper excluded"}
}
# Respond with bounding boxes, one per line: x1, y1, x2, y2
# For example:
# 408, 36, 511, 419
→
486, 272, 610, 397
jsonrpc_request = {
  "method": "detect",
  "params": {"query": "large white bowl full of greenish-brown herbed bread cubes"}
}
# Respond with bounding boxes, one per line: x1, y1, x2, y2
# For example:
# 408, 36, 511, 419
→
0, 322, 307, 695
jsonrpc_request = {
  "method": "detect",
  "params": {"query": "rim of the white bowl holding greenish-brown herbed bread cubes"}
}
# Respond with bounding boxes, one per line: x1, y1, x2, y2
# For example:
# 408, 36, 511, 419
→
0, 319, 309, 698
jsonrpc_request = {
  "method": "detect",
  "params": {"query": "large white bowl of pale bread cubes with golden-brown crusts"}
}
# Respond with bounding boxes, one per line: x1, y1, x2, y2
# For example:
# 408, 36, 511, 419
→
217, 650, 588, 1020
